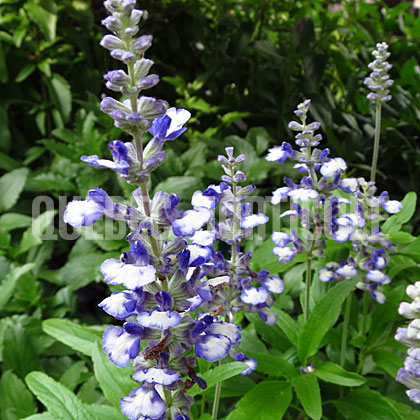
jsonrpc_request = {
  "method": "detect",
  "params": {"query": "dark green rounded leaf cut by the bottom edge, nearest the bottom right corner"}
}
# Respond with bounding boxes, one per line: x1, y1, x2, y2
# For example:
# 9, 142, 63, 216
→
334, 389, 403, 420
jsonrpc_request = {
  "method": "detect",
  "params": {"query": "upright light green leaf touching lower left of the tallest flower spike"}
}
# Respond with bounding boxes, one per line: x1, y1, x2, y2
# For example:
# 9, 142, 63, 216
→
92, 343, 138, 408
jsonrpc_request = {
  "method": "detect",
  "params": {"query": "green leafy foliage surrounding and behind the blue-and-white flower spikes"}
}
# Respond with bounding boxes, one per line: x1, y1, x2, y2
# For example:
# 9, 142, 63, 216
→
0, 0, 420, 420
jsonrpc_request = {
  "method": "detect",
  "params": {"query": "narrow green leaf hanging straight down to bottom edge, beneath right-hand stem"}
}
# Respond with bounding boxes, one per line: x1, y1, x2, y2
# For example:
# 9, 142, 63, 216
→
292, 373, 322, 420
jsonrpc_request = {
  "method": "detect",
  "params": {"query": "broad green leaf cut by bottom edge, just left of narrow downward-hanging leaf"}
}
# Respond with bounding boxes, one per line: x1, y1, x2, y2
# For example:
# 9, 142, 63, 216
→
226, 381, 292, 420
